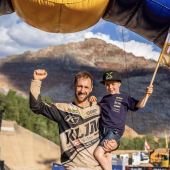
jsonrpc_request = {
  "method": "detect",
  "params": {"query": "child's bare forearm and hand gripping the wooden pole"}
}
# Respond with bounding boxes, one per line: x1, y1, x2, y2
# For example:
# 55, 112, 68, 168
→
136, 85, 153, 108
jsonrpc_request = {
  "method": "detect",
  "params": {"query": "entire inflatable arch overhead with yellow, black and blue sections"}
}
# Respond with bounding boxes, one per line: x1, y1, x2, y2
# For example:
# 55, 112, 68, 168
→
0, 0, 170, 48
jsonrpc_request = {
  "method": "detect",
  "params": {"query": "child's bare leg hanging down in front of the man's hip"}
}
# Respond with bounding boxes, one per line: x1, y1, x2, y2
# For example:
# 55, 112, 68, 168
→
94, 146, 112, 170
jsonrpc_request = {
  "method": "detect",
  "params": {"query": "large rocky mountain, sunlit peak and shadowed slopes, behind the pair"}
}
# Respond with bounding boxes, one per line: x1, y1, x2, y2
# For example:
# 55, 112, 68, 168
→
0, 39, 170, 136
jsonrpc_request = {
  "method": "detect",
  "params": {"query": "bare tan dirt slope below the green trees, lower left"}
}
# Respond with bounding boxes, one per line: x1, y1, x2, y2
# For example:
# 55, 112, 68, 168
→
0, 121, 60, 170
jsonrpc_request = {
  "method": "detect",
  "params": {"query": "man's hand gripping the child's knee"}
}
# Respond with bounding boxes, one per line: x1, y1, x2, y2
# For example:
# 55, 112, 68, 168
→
103, 139, 119, 152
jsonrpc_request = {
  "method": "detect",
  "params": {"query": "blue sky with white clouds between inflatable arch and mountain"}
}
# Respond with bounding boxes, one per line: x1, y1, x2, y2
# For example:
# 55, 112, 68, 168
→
0, 13, 160, 60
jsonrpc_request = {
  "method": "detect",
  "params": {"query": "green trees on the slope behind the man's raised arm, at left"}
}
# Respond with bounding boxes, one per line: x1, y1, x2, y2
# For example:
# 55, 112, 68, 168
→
0, 90, 59, 144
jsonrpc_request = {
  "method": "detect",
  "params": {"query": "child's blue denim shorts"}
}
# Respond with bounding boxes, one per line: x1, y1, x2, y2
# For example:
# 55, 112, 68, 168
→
99, 127, 121, 146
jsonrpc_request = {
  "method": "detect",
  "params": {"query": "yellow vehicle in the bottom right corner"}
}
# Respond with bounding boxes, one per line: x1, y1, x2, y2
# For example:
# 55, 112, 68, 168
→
150, 148, 170, 168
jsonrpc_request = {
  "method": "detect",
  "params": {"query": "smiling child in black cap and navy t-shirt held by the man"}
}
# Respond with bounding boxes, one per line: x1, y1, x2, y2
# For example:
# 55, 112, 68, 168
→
92, 71, 153, 170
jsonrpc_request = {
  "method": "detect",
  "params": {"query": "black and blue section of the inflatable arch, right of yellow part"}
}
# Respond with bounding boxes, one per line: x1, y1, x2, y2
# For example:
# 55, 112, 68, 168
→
103, 0, 170, 47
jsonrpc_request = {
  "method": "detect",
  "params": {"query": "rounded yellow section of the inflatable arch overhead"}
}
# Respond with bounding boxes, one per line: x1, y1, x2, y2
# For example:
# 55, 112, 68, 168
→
12, 0, 109, 33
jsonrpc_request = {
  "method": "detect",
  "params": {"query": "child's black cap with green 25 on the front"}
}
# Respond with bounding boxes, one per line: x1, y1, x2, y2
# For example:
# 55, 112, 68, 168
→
100, 71, 122, 84
